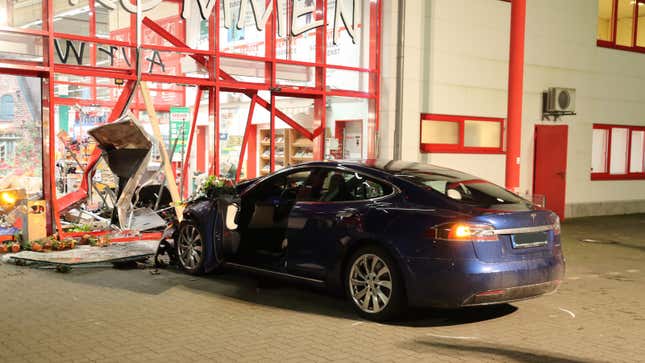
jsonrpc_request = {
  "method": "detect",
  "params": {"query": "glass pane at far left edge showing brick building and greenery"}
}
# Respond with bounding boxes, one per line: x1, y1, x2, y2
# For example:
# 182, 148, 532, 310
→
0, 74, 43, 195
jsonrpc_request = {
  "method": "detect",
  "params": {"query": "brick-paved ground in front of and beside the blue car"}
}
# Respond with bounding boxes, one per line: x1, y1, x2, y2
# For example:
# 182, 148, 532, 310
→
0, 215, 645, 363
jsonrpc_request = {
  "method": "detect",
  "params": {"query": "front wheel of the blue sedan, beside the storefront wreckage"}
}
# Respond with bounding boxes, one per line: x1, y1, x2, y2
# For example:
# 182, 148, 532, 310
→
175, 221, 205, 275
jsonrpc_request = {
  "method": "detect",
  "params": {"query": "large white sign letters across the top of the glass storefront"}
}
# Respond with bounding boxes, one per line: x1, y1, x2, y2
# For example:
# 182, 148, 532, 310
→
69, 0, 360, 44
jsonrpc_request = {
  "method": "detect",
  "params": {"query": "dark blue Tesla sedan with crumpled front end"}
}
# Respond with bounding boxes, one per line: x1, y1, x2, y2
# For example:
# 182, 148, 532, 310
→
165, 161, 565, 321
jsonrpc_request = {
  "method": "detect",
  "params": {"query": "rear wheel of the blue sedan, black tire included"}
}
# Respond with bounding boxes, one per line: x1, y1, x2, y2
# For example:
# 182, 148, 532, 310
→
344, 246, 405, 322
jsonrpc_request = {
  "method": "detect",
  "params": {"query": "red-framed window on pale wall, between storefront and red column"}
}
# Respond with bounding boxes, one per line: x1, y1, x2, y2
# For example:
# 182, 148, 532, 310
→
419, 113, 506, 154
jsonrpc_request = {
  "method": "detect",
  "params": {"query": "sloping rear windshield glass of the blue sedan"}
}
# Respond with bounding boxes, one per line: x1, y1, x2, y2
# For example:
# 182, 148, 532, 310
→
397, 172, 530, 207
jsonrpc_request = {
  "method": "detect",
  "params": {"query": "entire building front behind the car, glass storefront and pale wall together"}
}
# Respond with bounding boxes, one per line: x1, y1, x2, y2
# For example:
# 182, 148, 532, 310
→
0, 0, 645, 236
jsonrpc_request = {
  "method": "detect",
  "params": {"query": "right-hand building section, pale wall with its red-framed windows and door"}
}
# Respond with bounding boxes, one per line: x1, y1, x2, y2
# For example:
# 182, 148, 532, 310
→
379, 0, 645, 217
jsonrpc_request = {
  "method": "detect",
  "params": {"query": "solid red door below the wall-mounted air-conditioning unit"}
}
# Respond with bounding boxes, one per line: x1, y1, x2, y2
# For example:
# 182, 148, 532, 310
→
533, 125, 569, 219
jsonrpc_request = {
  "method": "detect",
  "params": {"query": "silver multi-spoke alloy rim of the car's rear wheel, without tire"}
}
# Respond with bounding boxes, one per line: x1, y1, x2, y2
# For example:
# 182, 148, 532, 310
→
349, 254, 392, 314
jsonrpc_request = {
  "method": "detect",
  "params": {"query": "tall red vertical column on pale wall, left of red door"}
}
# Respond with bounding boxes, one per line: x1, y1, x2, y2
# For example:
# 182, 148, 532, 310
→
506, 0, 526, 191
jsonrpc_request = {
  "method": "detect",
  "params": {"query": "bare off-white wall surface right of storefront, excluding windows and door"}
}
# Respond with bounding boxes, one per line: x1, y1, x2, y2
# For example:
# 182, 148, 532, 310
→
380, 0, 645, 217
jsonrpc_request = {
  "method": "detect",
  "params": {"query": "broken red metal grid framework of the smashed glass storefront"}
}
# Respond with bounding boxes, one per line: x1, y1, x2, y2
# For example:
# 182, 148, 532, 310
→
0, 0, 382, 236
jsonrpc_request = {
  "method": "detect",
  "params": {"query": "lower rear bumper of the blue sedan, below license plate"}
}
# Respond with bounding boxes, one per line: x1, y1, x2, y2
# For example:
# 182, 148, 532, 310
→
404, 254, 565, 308
